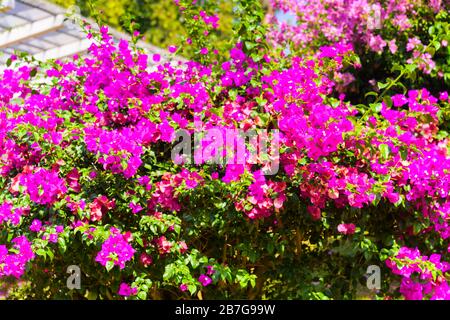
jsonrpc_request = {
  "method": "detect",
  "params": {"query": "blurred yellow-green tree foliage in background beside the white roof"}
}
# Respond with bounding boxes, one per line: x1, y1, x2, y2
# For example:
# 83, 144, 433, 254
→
51, 0, 239, 58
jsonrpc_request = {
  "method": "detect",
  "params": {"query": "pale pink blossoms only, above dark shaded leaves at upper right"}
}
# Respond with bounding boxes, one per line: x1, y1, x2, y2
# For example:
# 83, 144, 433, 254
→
266, 0, 449, 78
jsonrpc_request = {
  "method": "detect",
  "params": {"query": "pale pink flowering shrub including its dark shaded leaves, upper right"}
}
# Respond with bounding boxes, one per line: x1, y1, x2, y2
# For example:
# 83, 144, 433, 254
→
268, 0, 450, 104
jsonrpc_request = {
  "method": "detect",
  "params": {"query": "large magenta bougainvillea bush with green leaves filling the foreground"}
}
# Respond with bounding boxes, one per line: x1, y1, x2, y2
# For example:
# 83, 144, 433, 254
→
0, 0, 450, 299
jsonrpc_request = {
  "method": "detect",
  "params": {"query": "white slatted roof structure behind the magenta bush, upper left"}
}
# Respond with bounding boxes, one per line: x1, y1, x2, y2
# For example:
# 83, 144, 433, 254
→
0, 0, 168, 65
